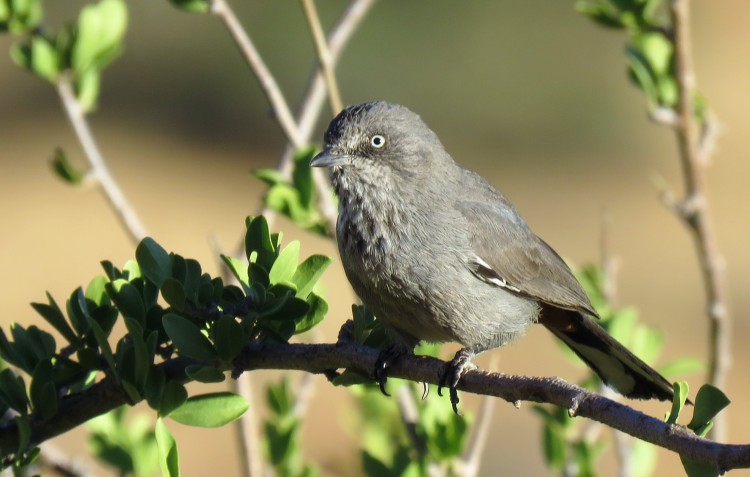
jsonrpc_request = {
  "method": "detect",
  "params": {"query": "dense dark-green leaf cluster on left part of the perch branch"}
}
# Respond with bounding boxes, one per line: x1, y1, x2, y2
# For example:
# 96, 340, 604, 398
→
0, 216, 331, 472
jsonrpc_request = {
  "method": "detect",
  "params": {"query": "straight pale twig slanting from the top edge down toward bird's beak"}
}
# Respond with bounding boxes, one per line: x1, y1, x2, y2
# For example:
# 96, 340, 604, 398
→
211, 0, 306, 149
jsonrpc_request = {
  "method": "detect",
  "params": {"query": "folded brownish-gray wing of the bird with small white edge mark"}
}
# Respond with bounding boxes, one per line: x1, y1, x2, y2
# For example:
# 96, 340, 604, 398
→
456, 199, 598, 316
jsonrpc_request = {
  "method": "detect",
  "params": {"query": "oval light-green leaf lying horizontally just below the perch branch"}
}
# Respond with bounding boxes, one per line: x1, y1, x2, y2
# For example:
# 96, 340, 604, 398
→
169, 392, 247, 427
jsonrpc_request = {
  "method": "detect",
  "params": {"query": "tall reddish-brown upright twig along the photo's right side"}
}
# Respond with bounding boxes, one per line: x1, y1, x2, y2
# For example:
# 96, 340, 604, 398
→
672, 0, 731, 440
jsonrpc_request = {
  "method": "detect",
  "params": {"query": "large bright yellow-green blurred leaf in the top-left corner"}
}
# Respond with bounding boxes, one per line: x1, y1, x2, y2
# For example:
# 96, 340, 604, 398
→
71, 0, 128, 75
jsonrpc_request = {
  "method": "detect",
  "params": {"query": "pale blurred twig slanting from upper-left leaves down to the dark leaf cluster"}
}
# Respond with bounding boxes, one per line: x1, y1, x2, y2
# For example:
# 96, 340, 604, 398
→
57, 75, 148, 243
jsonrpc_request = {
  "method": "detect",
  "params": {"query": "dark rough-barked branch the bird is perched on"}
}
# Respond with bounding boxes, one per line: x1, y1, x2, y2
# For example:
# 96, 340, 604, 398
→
0, 343, 750, 471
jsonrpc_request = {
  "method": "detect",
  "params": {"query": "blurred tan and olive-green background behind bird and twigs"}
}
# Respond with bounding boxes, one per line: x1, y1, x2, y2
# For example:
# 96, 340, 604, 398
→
0, 0, 750, 476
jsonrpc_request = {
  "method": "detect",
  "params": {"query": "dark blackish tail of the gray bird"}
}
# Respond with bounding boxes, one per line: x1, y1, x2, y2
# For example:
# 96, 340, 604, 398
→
539, 307, 674, 401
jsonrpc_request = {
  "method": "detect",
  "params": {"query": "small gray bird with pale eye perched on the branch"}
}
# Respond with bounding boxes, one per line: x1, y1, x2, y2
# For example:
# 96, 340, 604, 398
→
311, 101, 673, 410
